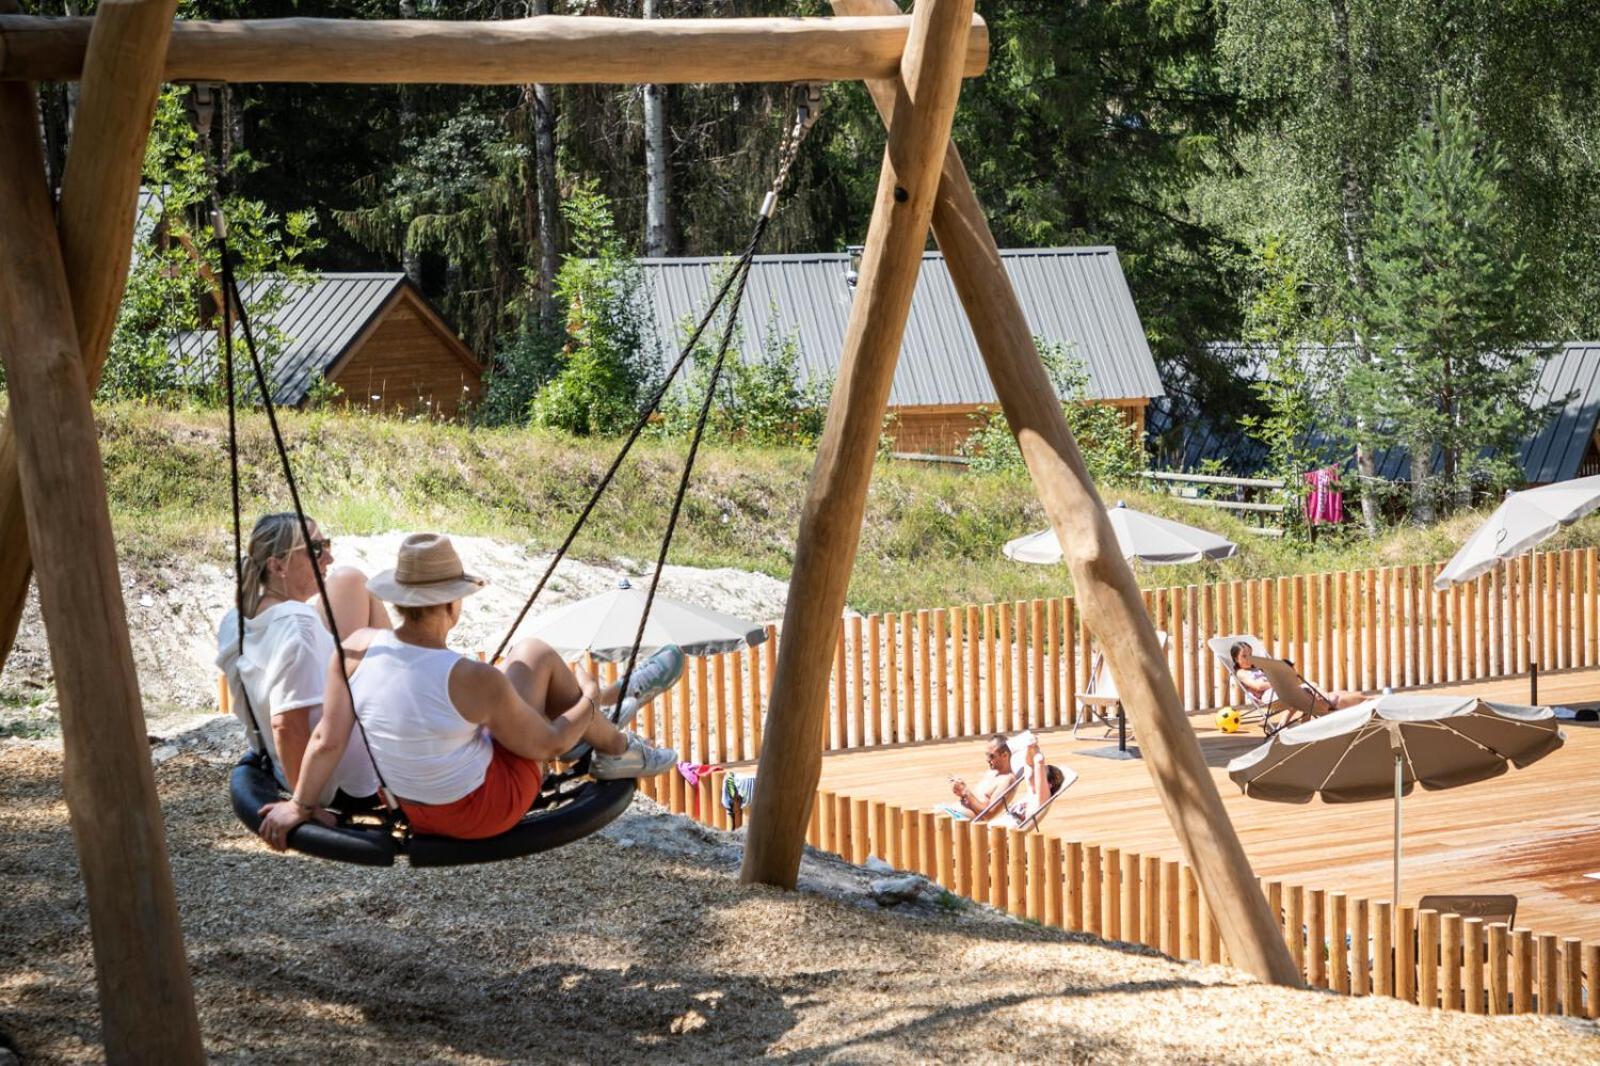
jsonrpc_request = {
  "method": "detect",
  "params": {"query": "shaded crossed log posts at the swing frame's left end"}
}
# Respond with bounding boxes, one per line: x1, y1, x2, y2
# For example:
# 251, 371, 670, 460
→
0, 0, 203, 1063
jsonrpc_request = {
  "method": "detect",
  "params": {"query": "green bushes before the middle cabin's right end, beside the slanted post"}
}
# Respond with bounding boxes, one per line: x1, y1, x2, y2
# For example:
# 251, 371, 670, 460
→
962, 338, 1149, 487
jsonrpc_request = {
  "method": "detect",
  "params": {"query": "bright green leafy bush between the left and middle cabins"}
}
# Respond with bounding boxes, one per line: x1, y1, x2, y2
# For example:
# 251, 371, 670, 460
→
528, 184, 659, 435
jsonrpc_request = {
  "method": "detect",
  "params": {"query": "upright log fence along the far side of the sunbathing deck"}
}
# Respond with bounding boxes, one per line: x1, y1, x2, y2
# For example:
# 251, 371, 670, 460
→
604, 547, 1600, 763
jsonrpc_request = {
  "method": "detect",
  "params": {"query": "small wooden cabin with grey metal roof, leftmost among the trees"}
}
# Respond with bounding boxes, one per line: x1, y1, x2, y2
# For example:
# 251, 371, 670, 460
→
171, 272, 483, 419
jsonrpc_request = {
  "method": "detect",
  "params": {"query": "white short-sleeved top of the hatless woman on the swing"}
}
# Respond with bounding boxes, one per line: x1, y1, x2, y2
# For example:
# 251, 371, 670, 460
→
216, 600, 378, 804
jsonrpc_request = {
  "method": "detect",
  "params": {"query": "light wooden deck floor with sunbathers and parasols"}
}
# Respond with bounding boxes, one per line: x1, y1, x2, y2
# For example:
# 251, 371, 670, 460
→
821, 669, 1600, 943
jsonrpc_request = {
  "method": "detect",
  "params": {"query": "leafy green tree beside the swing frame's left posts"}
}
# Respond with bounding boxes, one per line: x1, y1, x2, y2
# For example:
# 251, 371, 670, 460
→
99, 88, 320, 399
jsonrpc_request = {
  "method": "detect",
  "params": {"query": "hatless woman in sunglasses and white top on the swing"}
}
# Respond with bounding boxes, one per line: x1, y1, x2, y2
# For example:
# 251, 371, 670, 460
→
216, 512, 392, 807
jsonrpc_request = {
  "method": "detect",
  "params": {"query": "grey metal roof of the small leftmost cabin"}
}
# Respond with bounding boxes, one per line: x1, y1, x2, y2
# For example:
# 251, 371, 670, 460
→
168, 272, 408, 407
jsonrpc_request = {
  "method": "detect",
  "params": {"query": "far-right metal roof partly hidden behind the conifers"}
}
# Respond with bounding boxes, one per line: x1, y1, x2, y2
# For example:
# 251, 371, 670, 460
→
1147, 341, 1600, 485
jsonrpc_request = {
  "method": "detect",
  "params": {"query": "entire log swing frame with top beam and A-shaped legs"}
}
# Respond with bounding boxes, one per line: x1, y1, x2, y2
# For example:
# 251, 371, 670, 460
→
0, 0, 1299, 1063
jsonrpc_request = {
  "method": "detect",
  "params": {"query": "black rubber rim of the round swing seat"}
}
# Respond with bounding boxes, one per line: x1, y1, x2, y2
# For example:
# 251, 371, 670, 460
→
229, 752, 635, 868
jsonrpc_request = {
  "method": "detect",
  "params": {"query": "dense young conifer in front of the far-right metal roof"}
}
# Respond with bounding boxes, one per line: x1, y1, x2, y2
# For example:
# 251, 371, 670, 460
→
1349, 91, 1547, 520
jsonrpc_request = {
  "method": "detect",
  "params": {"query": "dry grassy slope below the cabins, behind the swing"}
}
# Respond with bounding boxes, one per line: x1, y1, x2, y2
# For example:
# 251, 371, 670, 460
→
90, 405, 1600, 610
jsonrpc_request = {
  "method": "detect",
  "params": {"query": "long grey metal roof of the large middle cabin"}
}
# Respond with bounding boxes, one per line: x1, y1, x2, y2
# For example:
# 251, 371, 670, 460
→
638, 248, 1162, 407
